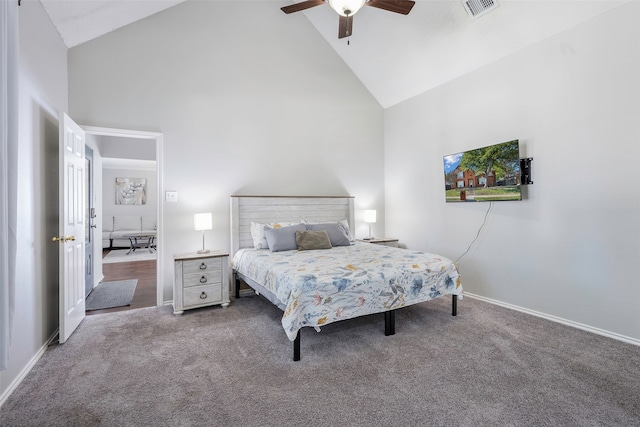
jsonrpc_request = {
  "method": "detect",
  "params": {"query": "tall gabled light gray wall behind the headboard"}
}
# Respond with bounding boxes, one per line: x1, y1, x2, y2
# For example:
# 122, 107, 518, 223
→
69, 1, 384, 301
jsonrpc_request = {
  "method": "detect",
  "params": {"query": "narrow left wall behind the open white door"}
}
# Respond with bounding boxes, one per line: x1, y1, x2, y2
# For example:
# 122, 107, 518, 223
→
0, 1, 67, 401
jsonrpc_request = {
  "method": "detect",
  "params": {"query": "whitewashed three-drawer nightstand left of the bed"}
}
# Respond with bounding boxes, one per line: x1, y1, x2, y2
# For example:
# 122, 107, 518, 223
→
173, 251, 229, 314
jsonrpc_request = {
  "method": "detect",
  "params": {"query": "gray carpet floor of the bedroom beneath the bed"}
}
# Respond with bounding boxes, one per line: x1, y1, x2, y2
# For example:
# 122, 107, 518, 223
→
0, 297, 640, 426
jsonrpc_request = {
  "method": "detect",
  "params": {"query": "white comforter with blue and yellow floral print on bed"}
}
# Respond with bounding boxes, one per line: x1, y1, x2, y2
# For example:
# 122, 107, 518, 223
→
231, 243, 462, 341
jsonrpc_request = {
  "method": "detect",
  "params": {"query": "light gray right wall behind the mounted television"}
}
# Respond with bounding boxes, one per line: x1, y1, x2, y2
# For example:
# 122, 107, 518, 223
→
385, 2, 640, 340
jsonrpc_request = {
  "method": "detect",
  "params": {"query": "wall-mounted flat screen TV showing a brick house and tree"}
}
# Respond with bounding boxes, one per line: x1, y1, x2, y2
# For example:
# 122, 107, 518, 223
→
444, 139, 522, 203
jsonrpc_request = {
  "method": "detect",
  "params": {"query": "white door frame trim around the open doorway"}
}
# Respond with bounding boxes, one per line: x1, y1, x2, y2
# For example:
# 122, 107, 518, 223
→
80, 125, 164, 307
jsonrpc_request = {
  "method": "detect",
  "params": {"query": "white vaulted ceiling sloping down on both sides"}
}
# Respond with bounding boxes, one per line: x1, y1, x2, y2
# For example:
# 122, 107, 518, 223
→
41, 0, 632, 108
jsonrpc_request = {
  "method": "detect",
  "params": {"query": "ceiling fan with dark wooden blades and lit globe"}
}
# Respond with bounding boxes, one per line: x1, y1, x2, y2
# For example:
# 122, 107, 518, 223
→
280, 0, 416, 39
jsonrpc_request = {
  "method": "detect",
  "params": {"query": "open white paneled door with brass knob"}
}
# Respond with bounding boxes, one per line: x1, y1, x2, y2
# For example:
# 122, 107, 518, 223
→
53, 113, 85, 343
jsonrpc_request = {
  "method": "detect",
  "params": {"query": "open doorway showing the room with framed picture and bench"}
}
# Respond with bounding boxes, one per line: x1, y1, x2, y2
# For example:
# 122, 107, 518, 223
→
83, 126, 163, 314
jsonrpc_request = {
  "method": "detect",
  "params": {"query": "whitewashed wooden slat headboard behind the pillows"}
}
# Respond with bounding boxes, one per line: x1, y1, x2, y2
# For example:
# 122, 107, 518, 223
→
231, 195, 355, 256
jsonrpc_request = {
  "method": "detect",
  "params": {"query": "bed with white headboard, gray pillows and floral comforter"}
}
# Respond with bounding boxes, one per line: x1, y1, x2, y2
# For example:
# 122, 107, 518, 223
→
231, 196, 462, 361
